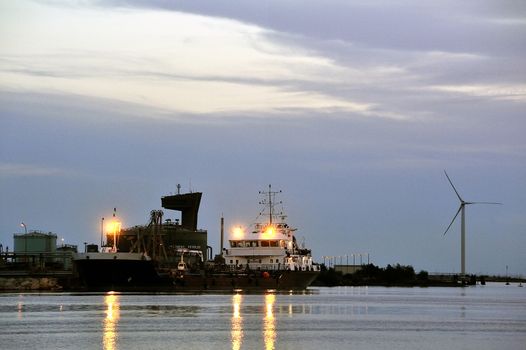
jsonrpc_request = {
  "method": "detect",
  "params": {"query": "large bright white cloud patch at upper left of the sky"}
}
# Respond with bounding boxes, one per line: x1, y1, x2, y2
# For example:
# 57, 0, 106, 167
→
0, 0, 384, 117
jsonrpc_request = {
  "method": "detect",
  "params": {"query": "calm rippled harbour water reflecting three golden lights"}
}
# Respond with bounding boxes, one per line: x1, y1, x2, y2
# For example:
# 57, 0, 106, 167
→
0, 284, 526, 350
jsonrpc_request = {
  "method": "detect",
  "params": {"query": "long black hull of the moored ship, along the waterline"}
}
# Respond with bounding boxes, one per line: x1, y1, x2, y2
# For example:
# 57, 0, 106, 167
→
75, 259, 319, 292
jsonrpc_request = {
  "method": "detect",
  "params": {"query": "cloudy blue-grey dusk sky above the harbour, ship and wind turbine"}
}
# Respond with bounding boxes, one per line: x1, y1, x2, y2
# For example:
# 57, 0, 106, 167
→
0, 0, 526, 276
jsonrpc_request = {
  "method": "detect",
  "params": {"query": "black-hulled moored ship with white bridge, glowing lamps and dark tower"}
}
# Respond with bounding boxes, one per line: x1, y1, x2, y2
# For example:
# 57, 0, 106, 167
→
74, 185, 320, 292
